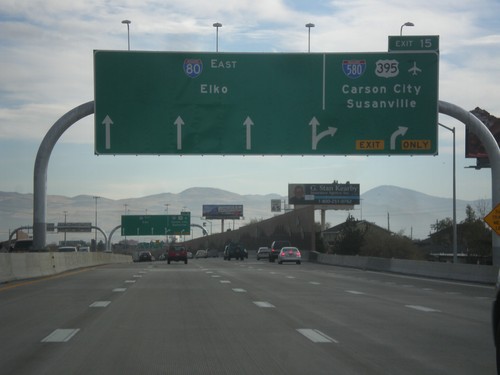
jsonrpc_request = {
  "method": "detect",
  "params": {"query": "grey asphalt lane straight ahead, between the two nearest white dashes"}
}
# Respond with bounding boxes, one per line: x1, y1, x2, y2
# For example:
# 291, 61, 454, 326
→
25, 265, 351, 374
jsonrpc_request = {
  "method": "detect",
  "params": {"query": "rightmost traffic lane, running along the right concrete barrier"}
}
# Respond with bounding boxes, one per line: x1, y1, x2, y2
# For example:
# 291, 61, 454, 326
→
227, 263, 494, 323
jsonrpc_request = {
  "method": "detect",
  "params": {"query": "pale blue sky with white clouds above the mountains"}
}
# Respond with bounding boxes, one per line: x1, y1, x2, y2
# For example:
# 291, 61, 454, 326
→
0, 0, 500, 207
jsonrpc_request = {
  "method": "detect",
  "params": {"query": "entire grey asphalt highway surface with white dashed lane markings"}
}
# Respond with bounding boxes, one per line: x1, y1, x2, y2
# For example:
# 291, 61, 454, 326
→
0, 258, 495, 375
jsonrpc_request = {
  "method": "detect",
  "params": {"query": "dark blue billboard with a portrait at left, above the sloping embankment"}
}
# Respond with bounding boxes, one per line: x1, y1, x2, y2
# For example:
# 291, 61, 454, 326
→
288, 183, 359, 206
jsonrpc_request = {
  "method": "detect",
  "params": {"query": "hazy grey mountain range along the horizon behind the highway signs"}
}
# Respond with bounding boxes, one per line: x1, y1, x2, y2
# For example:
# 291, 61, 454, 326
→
0, 185, 491, 242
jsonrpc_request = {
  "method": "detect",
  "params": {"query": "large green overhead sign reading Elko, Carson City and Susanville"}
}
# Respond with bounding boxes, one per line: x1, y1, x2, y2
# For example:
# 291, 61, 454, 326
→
94, 51, 438, 155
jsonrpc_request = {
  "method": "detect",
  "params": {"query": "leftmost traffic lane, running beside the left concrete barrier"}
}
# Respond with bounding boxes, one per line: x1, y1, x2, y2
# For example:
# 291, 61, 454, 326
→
0, 265, 155, 374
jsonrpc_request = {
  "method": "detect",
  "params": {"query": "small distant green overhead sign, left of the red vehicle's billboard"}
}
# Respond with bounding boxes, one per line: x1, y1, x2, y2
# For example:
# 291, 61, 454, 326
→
121, 214, 191, 236
